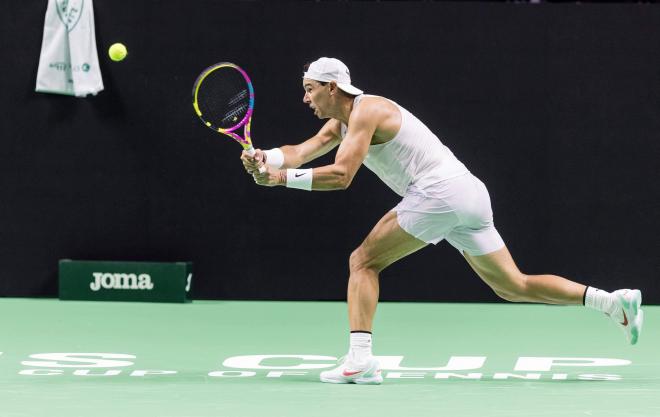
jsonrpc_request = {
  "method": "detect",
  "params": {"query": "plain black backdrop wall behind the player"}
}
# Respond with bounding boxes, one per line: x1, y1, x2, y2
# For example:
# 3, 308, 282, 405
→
0, 0, 660, 303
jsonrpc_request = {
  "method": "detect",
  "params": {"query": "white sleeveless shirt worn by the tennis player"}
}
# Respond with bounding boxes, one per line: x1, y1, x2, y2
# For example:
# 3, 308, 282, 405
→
341, 94, 470, 196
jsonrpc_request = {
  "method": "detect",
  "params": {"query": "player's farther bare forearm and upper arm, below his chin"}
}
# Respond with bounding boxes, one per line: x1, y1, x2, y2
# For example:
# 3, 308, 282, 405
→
280, 119, 341, 169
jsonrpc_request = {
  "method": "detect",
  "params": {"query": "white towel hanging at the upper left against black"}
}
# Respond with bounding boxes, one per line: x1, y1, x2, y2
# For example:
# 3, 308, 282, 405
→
36, 0, 103, 97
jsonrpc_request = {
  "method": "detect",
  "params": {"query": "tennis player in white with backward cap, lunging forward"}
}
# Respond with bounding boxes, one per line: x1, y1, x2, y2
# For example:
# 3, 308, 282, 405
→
241, 57, 643, 384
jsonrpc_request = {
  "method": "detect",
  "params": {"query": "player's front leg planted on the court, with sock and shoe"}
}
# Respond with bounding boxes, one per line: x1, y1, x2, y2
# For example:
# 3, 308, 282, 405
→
321, 211, 427, 384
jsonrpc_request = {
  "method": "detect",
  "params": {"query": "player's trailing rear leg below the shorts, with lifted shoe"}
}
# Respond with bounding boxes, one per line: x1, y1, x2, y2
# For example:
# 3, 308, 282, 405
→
464, 246, 644, 344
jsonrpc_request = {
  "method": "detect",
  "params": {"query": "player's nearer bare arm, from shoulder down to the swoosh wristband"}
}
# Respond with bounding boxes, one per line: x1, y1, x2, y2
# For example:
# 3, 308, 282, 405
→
312, 106, 378, 191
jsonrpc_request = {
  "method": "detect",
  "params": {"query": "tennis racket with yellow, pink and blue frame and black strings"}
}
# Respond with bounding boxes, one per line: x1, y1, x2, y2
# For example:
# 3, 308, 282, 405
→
193, 62, 266, 173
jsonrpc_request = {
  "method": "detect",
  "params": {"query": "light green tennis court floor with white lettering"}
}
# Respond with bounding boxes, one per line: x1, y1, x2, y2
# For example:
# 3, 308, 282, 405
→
0, 299, 660, 417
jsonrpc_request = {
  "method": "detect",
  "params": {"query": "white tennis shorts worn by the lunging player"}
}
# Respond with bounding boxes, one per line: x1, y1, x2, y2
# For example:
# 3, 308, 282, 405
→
393, 173, 504, 256
